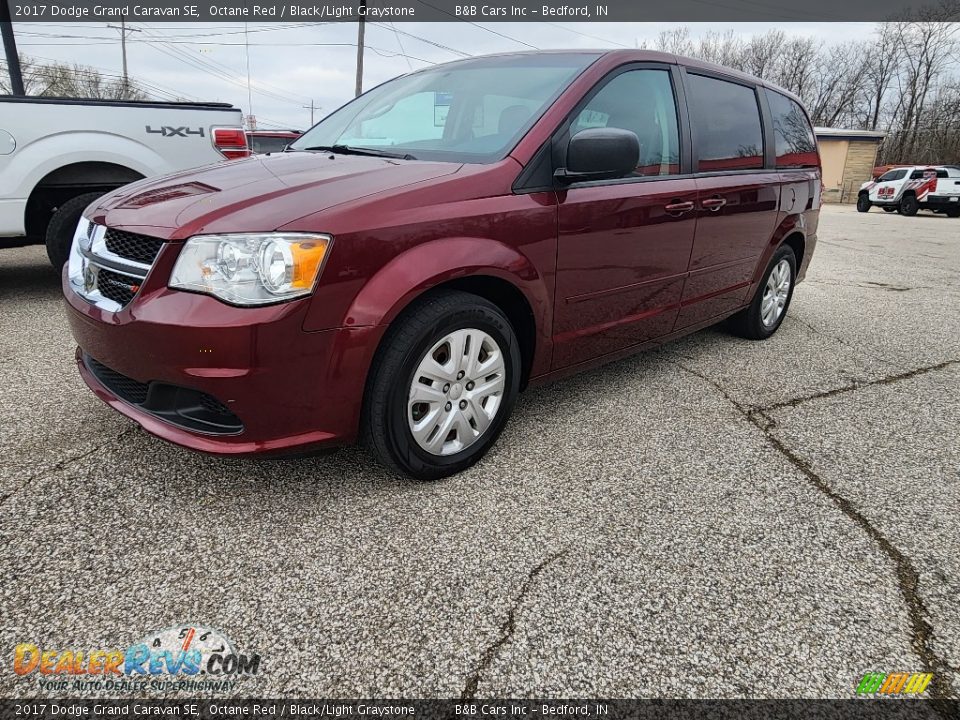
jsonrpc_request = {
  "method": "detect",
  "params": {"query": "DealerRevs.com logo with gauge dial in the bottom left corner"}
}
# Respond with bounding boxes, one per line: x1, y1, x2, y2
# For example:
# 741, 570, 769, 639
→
13, 625, 260, 691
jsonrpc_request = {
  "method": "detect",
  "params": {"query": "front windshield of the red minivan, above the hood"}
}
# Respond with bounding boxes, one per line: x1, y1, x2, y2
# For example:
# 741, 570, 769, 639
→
290, 53, 597, 163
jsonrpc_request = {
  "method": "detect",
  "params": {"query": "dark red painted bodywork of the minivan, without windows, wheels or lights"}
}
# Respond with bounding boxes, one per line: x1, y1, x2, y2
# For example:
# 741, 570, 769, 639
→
64, 51, 820, 453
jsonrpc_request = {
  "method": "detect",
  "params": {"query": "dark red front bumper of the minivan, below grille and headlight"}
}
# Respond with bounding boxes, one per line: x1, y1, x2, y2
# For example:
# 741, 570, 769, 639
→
63, 245, 383, 454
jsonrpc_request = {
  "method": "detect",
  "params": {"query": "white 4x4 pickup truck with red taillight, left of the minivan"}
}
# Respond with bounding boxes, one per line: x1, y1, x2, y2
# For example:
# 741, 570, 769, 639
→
0, 95, 249, 269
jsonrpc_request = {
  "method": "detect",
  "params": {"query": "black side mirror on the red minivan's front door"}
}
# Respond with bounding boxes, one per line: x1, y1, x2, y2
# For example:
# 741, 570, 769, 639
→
555, 128, 640, 182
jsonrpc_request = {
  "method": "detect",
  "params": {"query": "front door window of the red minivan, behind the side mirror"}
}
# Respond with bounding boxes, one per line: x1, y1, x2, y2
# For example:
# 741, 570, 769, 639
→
570, 70, 680, 175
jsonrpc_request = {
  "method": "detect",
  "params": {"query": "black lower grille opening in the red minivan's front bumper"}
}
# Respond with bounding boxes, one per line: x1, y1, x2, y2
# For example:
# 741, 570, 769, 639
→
83, 355, 243, 435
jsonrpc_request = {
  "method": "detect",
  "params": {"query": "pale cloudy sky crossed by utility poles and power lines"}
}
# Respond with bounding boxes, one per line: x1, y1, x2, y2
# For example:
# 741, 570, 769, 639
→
14, 22, 873, 129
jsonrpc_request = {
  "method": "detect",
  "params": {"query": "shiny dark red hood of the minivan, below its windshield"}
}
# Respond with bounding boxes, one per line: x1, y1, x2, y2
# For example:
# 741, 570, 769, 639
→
90, 152, 462, 240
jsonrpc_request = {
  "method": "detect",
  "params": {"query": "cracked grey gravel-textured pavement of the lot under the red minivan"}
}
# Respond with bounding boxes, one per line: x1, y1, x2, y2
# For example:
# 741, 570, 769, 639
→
0, 206, 960, 697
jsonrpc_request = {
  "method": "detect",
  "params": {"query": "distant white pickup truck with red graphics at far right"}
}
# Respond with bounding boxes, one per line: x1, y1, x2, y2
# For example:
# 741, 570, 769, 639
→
857, 165, 960, 217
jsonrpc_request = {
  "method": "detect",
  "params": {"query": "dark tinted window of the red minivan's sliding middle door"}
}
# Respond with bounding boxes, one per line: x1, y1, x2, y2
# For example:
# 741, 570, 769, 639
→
687, 75, 763, 172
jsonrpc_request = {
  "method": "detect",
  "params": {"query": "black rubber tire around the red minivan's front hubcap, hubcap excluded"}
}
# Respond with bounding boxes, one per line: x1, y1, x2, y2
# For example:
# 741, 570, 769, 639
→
361, 290, 520, 480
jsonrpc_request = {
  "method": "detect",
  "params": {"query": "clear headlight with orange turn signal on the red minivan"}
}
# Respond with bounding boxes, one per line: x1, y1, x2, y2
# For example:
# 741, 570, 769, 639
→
169, 233, 333, 305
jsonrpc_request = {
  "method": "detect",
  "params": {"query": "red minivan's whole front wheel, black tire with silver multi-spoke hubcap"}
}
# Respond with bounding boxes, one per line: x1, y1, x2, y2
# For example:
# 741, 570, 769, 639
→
361, 291, 520, 480
